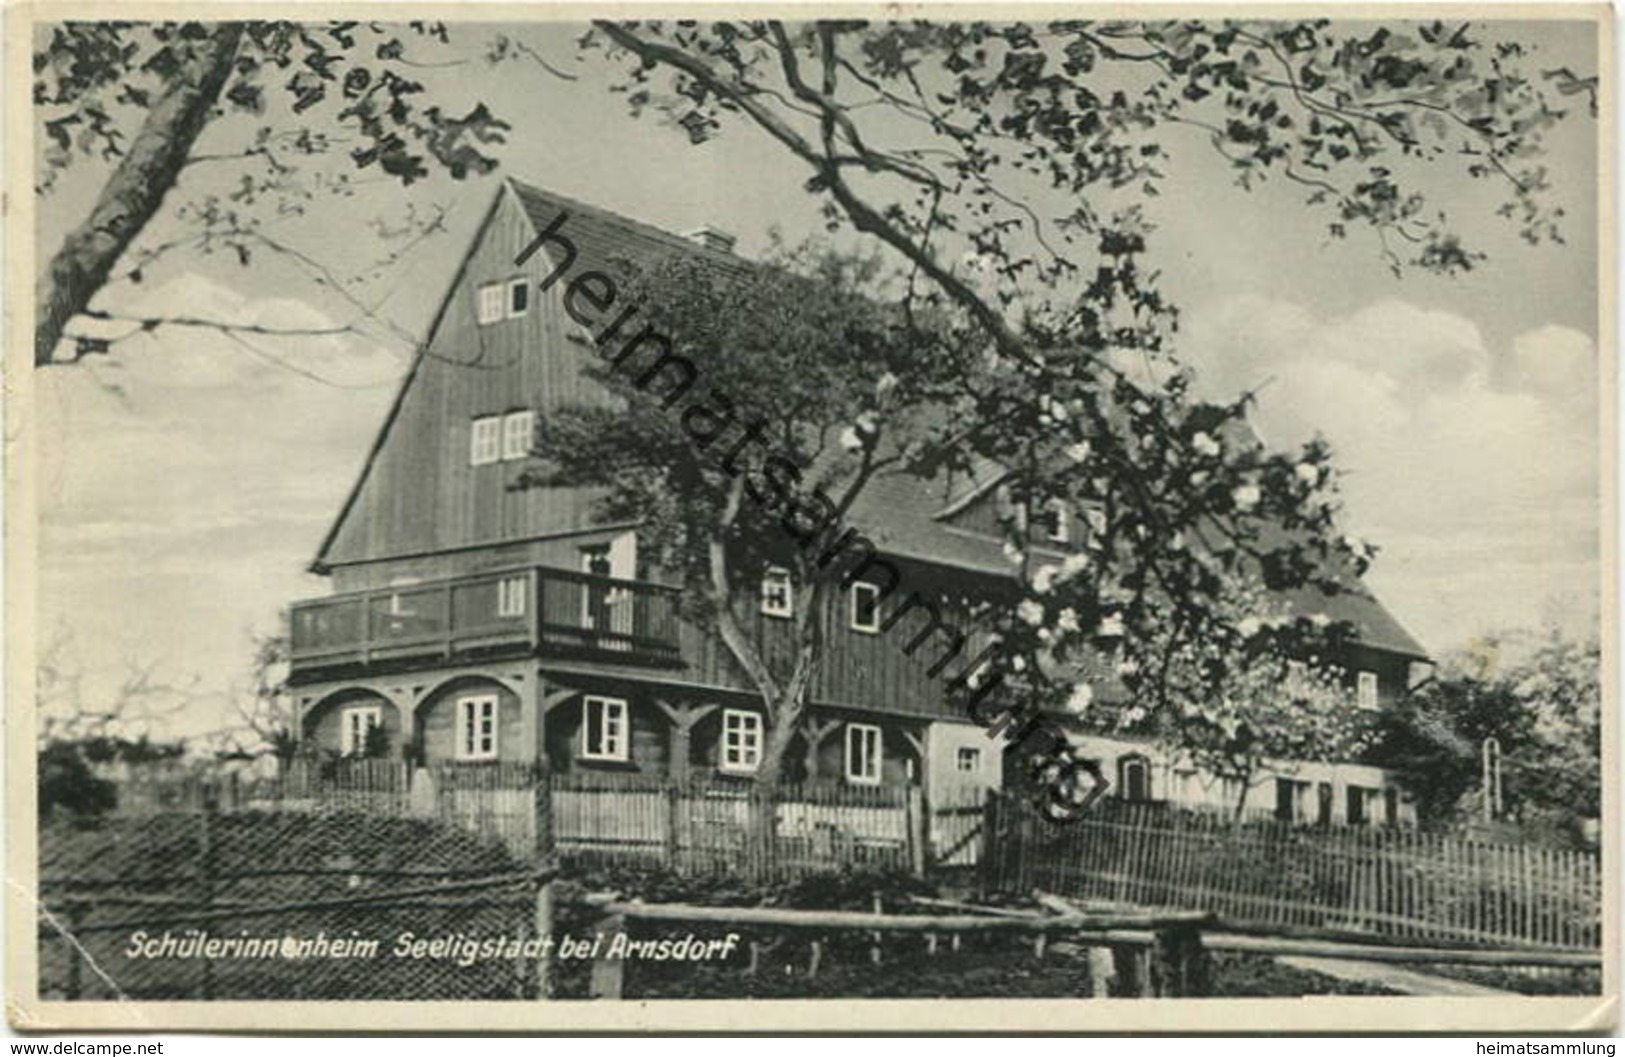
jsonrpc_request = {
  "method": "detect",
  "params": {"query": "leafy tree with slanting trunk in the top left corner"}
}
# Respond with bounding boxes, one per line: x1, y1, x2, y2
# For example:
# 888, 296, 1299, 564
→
33, 20, 510, 364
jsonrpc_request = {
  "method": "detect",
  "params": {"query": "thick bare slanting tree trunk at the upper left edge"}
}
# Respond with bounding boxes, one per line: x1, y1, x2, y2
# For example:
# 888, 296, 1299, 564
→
34, 23, 242, 366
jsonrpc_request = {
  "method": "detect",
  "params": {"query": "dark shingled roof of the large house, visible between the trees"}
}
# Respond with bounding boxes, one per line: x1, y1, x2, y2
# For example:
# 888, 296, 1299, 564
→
509, 179, 1427, 659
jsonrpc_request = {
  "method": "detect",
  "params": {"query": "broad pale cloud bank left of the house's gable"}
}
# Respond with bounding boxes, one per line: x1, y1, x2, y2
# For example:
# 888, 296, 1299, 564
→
37, 275, 405, 727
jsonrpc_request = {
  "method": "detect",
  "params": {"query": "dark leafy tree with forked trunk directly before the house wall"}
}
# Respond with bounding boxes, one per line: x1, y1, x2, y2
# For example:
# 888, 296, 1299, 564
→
522, 246, 977, 782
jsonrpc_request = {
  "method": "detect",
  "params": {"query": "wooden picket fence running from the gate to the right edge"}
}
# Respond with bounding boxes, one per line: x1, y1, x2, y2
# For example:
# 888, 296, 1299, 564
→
982, 795, 1602, 950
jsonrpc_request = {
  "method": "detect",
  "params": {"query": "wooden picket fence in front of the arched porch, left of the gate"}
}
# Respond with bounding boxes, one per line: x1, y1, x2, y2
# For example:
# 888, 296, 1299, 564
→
119, 759, 929, 880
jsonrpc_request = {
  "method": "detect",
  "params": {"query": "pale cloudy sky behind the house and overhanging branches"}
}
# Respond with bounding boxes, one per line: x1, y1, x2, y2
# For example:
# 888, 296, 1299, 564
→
39, 18, 1599, 741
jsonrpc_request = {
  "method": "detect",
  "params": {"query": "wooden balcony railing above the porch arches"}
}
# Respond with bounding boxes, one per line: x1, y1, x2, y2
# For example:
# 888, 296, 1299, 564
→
289, 568, 681, 670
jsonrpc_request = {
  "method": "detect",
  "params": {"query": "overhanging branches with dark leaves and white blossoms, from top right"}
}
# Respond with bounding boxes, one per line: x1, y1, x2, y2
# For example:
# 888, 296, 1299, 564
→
583, 20, 1571, 774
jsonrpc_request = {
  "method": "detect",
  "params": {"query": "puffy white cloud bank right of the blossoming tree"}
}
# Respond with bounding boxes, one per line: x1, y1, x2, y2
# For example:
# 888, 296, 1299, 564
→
1186, 298, 1599, 649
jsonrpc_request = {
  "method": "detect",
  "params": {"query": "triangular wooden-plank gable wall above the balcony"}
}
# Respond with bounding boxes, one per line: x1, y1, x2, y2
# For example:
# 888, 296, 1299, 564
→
315, 185, 620, 590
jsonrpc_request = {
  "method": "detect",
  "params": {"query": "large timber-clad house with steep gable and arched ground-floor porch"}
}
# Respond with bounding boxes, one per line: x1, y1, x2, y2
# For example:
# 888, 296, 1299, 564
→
289, 181, 1424, 822
